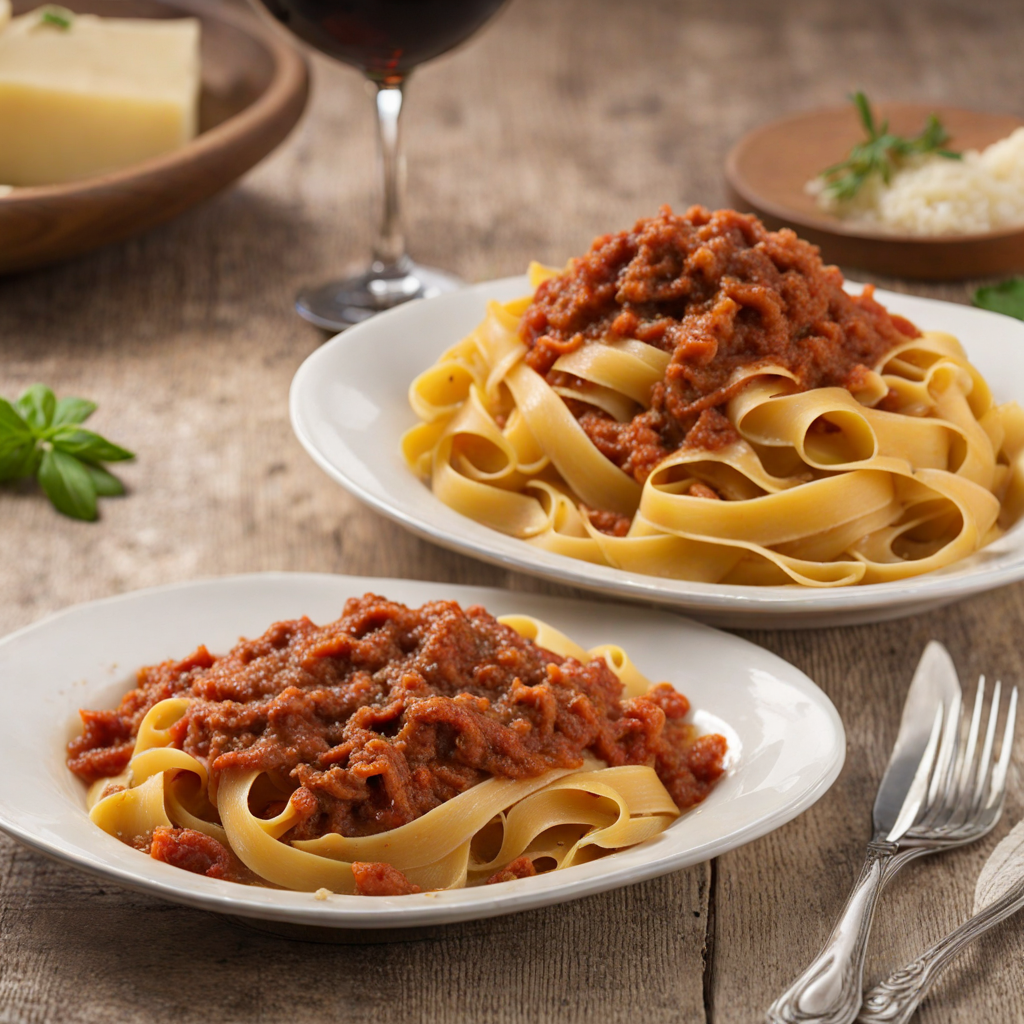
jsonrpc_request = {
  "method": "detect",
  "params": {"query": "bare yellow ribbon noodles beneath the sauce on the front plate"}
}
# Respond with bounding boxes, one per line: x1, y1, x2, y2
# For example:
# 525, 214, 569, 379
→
73, 595, 724, 894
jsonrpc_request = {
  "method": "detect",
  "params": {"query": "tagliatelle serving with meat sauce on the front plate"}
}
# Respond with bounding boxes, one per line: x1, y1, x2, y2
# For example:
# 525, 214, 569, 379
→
69, 595, 725, 895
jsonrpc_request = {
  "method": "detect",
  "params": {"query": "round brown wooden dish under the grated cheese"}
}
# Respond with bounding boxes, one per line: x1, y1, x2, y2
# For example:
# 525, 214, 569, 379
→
725, 103, 1024, 281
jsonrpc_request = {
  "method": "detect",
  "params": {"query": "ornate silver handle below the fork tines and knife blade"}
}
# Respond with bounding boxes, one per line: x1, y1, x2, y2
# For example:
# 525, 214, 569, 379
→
767, 838, 909, 1024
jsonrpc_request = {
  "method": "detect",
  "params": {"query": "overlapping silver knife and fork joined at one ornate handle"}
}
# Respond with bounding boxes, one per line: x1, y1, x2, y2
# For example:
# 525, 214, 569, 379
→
767, 640, 1017, 1024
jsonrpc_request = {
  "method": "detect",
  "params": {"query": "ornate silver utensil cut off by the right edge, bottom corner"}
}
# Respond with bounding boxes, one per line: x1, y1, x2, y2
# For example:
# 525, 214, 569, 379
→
857, 821, 1024, 1024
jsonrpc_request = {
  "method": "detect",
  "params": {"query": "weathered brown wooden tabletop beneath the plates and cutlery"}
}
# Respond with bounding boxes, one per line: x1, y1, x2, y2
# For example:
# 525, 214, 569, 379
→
0, 0, 1024, 1024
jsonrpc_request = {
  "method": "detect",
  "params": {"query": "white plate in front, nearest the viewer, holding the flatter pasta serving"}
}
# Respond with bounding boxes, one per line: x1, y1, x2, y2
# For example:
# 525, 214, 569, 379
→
0, 573, 846, 929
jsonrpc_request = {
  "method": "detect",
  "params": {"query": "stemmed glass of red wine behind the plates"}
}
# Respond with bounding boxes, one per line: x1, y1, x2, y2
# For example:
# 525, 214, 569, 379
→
253, 0, 505, 331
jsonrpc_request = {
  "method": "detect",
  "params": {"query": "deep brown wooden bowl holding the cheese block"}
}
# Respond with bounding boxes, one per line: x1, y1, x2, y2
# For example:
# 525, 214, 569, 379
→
0, 0, 309, 273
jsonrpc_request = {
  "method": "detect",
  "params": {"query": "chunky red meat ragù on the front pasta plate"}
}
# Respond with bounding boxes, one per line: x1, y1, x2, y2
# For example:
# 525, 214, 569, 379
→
68, 594, 726, 893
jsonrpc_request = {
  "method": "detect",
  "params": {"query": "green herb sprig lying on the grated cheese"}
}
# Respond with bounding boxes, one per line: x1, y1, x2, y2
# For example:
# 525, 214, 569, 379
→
818, 90, 963, 202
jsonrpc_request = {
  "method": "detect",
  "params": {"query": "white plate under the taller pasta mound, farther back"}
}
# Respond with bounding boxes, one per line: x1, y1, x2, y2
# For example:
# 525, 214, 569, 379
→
291, 278, 1024, 629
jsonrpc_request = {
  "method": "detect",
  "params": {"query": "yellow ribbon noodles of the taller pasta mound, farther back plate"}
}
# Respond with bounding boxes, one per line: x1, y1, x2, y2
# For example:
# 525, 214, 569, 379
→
402, 211, 1024, 587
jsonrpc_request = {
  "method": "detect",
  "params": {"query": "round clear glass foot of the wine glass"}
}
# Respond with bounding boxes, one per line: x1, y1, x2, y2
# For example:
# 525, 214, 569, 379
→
295, 259, 464, 331
